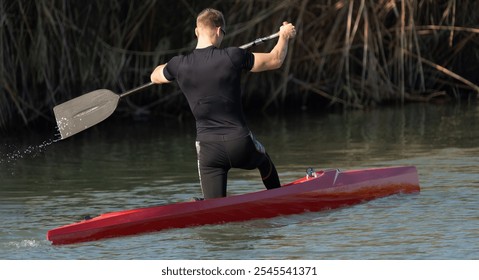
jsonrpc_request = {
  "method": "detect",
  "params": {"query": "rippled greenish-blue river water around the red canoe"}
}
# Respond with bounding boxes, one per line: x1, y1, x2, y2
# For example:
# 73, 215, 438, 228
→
0, 104, 479, 260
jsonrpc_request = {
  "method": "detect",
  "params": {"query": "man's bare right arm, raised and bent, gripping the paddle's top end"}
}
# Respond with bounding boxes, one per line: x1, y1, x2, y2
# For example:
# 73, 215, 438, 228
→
251, 22, 296, 72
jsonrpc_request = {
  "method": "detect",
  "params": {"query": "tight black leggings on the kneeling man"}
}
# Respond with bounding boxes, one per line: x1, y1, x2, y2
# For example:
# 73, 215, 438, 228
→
196, 135, 281, 199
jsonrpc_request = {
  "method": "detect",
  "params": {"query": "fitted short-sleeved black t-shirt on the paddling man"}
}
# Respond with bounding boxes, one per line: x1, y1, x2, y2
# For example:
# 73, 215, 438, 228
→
163, 46, 254, 141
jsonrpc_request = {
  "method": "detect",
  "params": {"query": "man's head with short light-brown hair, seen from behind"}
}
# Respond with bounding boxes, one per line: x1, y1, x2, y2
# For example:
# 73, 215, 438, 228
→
195, 8, 226, 47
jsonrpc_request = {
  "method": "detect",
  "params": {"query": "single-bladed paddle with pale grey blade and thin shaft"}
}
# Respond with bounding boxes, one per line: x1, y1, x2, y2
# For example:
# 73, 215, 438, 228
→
53, 32, 279, 139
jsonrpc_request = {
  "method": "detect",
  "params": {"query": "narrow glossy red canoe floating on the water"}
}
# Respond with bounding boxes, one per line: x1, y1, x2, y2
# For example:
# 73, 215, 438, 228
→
47, 166, 419, 244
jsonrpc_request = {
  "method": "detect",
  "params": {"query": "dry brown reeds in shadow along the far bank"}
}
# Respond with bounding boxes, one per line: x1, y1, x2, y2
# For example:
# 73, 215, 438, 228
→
0, 0, 479, 128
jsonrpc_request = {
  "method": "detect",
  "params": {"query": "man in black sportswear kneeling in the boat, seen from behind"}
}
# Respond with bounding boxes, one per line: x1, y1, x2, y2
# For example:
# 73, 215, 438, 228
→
151, 9, 296, 199
